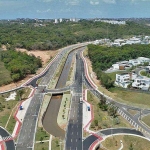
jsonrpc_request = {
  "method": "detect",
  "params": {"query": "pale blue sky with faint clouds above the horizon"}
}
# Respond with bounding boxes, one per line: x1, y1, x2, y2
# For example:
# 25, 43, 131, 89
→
0, 0, 150, 19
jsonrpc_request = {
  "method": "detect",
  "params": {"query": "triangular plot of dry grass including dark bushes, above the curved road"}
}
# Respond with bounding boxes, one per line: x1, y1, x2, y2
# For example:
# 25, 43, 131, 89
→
87, 91, 131, 130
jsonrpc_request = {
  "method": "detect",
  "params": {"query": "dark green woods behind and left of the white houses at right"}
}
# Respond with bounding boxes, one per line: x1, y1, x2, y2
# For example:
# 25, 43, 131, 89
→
88, 44, 150, 89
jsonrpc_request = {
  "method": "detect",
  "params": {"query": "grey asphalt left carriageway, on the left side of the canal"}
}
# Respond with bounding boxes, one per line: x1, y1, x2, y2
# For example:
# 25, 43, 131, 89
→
16, 45, 86, 150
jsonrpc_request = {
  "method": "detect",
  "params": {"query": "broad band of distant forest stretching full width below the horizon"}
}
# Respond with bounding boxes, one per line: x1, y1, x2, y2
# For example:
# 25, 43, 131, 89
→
0, 20, 150, 50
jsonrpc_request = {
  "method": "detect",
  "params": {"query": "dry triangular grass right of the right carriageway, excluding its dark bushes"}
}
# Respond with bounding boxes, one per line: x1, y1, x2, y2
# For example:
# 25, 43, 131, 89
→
87, 91, 131, 130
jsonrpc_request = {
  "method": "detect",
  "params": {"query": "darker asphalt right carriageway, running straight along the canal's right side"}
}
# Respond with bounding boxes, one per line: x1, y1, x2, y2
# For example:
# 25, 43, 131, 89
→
65, 48, 84, 150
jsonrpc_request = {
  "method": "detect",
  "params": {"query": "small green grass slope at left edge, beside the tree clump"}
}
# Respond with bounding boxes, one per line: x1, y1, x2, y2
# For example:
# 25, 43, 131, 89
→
0, 60, 12, 86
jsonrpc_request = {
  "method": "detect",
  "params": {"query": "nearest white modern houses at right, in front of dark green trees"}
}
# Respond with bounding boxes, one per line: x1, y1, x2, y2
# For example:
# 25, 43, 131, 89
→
111, 57, 150, 90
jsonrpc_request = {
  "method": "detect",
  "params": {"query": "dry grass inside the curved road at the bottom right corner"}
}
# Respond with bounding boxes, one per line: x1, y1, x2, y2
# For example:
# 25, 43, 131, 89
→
102, 135, 150, 150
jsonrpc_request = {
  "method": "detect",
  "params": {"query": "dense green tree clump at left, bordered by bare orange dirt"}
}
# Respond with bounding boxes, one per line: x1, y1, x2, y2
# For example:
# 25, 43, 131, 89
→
0, 50, 42, 81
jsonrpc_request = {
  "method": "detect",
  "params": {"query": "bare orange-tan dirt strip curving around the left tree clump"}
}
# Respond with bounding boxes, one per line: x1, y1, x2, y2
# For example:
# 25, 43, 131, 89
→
0, 46, 60, 92
